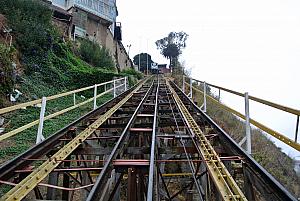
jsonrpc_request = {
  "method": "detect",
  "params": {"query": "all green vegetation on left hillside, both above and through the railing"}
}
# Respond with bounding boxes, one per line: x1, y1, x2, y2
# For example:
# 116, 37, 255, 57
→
0, 0, 142, 164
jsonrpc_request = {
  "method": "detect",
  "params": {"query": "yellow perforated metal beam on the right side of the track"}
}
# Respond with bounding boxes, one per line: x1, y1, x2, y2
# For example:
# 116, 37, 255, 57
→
167, 81, 247, 201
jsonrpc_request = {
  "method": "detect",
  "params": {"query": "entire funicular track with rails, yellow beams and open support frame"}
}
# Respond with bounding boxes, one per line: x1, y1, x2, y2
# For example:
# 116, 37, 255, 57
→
0, 76, 296, 201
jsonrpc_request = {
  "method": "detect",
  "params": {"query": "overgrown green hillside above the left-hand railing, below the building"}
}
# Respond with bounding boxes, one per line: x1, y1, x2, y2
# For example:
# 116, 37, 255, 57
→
0, 0, 141, 107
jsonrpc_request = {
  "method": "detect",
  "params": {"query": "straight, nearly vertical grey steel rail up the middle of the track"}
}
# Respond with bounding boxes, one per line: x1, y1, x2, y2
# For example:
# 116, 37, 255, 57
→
147, 77, 160, 201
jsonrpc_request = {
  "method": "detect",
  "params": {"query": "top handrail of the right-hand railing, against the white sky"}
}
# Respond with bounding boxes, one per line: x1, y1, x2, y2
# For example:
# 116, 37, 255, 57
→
191, 78, 300, 116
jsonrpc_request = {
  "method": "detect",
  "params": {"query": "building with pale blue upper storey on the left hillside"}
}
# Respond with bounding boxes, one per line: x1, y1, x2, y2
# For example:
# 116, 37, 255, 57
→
44, 0, 133, 70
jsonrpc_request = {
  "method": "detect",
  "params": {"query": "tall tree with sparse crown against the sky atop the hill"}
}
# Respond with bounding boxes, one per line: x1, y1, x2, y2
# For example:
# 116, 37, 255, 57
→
155, 31, 188, 71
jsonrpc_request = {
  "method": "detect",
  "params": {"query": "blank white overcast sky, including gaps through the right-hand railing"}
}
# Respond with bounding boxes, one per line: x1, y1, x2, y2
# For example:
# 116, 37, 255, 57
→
117, 0, 300, 157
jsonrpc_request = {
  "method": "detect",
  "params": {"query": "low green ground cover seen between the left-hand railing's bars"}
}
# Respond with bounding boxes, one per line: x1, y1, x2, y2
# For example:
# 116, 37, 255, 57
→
0, 86, 112, 164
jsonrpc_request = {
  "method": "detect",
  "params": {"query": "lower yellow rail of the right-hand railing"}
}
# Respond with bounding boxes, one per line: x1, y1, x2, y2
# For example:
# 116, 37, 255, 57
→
193, 86, 300, 151
